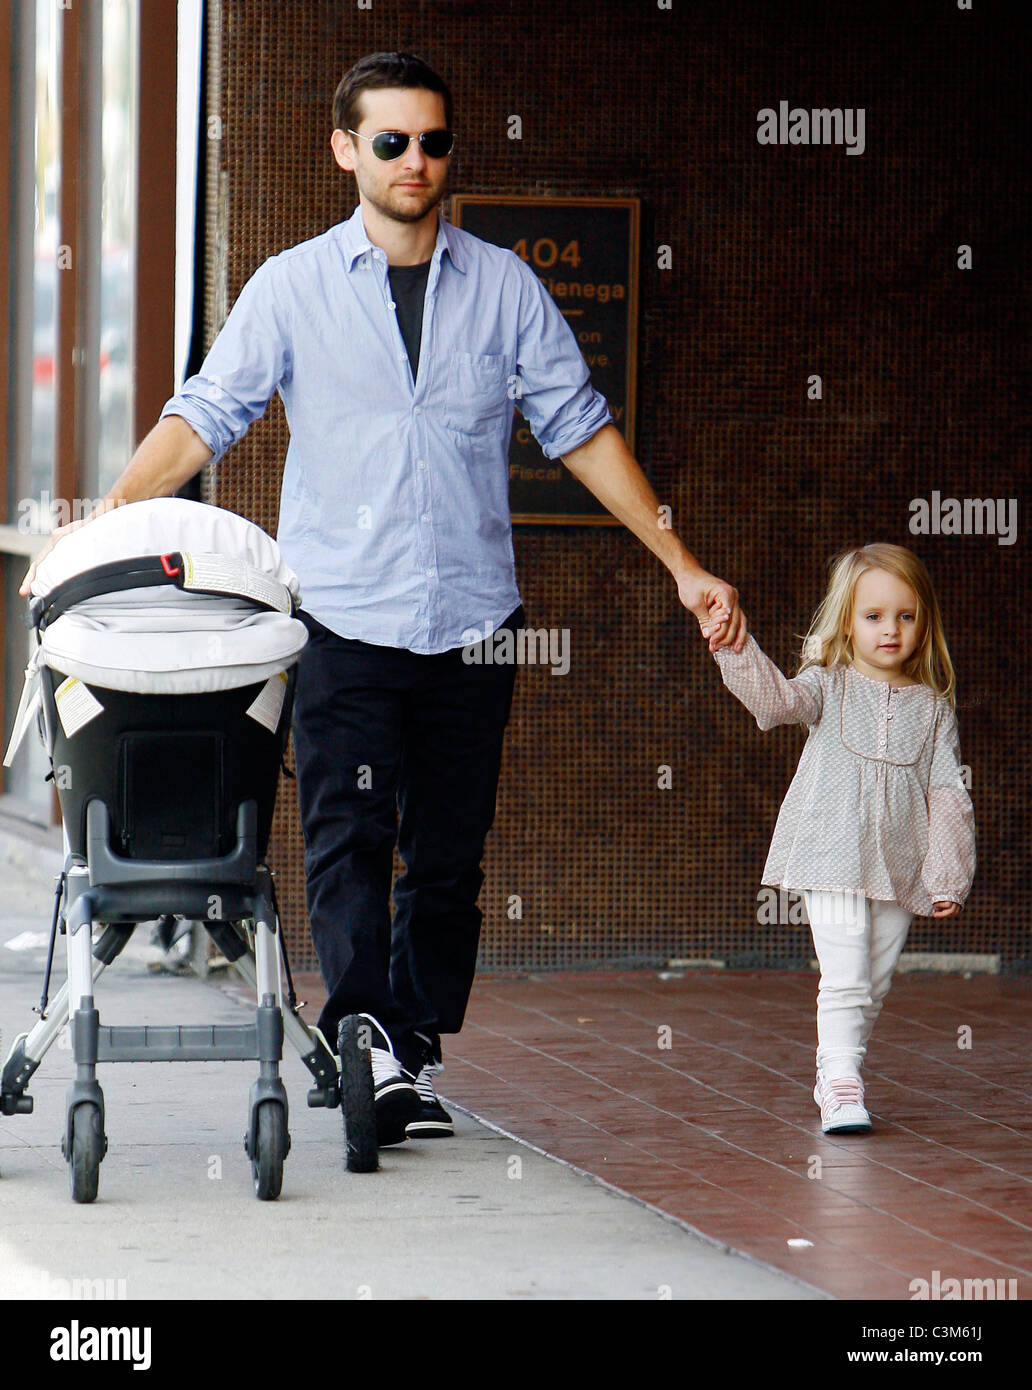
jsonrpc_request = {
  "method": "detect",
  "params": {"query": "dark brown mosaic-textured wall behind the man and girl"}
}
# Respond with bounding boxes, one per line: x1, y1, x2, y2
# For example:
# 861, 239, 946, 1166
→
206, 0, 1029, 970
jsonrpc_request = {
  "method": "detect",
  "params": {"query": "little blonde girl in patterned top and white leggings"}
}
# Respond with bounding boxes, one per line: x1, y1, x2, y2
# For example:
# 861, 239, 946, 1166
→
704, 545, 975, 1134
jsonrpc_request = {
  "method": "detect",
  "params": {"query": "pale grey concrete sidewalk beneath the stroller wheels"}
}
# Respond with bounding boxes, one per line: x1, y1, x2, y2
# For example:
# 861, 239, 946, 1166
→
0, 831, 826, 1300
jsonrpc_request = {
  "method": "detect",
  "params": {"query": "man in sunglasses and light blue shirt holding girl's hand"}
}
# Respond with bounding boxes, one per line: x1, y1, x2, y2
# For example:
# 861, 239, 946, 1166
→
22, 53, 745, 1144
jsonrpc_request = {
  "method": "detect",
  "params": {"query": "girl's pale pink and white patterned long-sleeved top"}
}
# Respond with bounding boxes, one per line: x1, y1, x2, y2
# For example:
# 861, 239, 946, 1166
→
713, 634, 976, 916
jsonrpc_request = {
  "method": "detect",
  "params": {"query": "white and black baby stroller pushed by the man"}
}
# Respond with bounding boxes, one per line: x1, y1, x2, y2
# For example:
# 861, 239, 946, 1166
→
0, 498, 378, 1202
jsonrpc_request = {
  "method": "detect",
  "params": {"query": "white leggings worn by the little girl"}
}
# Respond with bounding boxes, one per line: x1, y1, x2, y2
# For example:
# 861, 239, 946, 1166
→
803, 888, 912, 1080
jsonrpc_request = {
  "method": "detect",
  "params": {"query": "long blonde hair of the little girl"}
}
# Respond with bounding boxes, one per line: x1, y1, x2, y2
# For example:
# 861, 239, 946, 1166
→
800, 541, 957, 705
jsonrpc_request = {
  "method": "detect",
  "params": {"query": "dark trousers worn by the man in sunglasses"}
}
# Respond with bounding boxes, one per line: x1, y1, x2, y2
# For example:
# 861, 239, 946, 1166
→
293, 607, 523, 1061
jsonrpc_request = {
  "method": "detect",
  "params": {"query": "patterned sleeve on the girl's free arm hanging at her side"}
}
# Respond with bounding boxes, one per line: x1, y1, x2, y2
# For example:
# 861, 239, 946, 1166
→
921, 702, 976, 906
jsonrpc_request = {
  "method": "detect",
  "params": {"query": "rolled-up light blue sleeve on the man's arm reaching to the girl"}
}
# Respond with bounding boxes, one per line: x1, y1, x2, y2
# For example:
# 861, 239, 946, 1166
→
515, 257, 613, 459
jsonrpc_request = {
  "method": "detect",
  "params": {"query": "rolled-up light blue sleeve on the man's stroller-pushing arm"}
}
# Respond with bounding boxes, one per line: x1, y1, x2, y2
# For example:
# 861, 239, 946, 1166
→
159, 257, 291, 461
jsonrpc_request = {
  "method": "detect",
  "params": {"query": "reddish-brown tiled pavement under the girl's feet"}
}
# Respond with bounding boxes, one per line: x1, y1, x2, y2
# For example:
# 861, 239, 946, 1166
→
285, 972, 1032, 1300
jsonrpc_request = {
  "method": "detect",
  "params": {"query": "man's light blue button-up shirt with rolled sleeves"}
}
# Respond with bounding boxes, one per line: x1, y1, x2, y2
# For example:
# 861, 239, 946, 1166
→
161, 204, 612, 652
